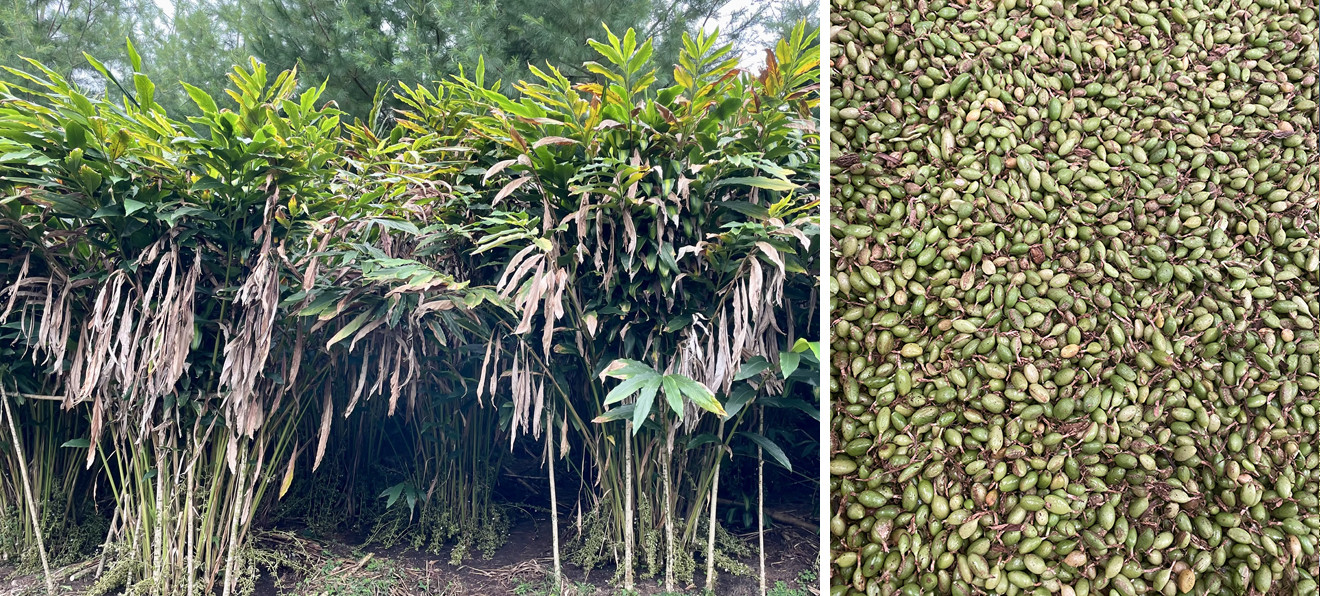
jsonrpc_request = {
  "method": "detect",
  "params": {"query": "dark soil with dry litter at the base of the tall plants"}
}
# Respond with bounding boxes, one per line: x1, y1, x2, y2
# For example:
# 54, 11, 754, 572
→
0, 472, 820, 596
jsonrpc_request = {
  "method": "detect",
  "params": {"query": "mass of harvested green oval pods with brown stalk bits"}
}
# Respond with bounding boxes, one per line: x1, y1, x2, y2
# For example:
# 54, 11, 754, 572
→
830, 0, 1320, 596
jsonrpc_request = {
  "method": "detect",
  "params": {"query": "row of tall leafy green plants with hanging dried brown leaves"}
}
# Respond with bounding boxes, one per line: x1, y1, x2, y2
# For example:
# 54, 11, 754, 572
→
0, 25, 820, 596
